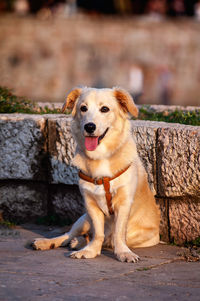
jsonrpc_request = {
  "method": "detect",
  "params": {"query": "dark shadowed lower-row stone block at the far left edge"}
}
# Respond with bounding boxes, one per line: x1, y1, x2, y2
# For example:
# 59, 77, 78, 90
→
0, 181, 48, 222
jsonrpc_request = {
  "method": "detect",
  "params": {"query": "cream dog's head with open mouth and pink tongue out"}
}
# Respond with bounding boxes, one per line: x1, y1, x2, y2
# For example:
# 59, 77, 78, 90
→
63, 88, 138, 159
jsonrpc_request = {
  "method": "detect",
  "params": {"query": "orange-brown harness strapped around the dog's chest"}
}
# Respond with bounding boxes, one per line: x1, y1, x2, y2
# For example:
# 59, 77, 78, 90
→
79, 165, 130, 215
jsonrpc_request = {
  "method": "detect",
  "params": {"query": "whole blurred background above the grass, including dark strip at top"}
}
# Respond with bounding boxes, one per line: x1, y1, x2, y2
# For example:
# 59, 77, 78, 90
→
0, 0, 200, 106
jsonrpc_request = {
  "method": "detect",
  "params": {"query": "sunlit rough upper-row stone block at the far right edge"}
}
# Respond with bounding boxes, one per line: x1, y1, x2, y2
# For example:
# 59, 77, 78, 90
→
156, 124, 200, 197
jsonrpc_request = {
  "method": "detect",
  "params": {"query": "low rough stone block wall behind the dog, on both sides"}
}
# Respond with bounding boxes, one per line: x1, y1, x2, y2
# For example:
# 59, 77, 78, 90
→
0, 114, 200, 244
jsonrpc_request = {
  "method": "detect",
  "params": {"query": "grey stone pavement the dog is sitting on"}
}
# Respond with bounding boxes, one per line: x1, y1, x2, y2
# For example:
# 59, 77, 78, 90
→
0, 224, 200, 301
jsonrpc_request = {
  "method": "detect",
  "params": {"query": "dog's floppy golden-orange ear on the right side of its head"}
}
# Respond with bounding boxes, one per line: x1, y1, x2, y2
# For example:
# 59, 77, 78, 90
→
113, 87, 138, 117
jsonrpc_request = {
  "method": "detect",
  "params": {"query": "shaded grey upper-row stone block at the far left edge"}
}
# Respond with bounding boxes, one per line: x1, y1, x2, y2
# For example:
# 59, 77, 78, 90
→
0, 114, 46, 181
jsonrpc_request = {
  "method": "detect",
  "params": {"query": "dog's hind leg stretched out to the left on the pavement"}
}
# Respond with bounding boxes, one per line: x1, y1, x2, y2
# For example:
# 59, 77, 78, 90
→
31, 214, 91, 250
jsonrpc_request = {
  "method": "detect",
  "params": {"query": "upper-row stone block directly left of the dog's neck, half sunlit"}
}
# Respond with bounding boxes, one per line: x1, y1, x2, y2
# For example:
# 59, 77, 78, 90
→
48, 115, 78, 185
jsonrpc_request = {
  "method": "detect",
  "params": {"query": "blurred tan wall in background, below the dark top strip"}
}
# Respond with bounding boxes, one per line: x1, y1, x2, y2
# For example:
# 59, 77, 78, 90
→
0, 16, 200, 105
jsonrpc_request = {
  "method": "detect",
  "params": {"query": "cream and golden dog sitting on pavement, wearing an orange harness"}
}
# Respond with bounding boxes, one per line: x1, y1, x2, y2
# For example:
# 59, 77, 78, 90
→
33, 87, 160, 262
